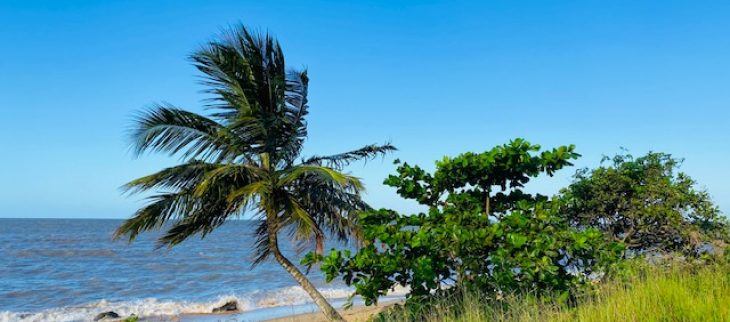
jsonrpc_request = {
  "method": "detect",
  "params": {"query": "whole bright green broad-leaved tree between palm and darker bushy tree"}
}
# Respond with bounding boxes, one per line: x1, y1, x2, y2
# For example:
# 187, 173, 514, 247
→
303, 139, 623, 304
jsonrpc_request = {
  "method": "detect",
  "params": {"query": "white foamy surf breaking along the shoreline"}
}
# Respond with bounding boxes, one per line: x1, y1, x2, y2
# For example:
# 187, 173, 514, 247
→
0, 286, 352, 322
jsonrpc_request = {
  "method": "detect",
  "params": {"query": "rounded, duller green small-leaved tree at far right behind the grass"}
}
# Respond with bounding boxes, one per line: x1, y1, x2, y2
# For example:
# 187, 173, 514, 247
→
562, 153, 728, 254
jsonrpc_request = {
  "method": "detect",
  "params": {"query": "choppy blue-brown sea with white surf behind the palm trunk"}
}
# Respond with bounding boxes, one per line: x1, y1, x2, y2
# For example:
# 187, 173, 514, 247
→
0, 219, 402, 322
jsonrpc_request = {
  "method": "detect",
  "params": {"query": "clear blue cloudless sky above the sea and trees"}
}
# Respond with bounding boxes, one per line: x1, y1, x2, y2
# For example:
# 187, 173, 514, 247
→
0, 0, 730, 218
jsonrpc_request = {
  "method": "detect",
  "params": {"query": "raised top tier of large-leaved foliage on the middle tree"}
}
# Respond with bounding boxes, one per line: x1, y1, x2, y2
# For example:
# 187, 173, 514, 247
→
384, 139, 580, 217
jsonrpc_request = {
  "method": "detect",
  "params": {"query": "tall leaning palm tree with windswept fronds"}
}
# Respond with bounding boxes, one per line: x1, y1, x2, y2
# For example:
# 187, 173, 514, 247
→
115, 26, 395, 321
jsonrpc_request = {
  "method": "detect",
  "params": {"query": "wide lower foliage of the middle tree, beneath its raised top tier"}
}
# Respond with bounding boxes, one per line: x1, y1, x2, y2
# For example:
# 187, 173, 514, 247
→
303, 201, 623, 306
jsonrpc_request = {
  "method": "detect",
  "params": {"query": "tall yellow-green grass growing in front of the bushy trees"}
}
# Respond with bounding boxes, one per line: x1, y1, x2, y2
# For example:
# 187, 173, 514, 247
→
381, 263, 730, 322
